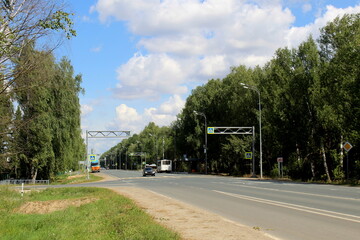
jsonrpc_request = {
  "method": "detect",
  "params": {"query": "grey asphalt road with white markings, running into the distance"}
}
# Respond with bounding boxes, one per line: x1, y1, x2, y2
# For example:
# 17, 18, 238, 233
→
75, 170, 360, 240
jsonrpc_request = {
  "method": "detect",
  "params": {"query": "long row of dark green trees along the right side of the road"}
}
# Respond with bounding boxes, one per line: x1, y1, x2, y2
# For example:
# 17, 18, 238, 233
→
103, 14, 360, 182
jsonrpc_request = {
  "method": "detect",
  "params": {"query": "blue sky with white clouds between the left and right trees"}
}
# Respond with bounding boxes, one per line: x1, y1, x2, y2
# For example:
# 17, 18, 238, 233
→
56, 0, 360, 154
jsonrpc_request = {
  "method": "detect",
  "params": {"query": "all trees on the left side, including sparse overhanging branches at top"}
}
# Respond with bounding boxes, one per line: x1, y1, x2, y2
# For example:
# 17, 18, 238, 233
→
0, 0, 85, 180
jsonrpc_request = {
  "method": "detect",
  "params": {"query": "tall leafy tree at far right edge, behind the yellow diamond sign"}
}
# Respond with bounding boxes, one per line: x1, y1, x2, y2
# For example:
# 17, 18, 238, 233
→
319, 13, 360, 178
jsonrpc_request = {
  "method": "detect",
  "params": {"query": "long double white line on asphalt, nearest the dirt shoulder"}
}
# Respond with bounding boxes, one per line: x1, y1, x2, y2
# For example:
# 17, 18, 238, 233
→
212, 190, 360, 223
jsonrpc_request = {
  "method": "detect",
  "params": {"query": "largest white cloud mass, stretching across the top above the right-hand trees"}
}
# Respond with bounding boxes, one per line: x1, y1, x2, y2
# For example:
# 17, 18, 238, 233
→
91, 0, 359, 100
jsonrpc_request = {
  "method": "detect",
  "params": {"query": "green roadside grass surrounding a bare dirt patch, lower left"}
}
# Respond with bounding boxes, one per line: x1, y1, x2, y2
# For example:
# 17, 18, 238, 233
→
0, 187, 180, 240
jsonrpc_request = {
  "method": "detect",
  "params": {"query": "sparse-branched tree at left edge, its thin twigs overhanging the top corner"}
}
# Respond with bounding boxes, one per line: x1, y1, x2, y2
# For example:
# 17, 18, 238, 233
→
0, 0, 76, 179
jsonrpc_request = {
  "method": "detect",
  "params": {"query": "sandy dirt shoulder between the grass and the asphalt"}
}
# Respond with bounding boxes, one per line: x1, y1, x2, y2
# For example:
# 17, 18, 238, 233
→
95, 173, 276, 240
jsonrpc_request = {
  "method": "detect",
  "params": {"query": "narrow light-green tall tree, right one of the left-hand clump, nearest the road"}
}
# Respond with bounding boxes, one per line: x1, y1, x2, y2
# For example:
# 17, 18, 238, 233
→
50, 58, 84, 173
